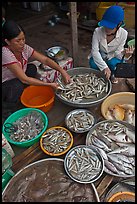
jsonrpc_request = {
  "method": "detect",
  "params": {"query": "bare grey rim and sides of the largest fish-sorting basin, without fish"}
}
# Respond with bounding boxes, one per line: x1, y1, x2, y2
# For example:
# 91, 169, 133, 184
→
56, 67, 112, 108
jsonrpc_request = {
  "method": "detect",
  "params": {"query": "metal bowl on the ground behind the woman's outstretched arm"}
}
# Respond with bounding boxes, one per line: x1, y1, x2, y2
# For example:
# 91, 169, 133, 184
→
45, 46, 69, 61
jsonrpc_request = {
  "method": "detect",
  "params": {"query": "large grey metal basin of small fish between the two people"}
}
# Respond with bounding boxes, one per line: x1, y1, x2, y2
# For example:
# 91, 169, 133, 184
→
56, 67, 112, 108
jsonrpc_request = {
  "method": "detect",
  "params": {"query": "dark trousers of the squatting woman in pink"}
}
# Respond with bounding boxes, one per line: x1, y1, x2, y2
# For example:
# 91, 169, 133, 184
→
2, 64, 37, 103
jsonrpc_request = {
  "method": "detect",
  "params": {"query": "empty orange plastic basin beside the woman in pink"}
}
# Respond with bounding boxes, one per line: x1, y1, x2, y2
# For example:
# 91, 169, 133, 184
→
21, 86, 55, 112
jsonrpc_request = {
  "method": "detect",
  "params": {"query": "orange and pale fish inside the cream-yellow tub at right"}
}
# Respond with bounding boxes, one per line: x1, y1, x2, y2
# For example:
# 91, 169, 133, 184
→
106, 104, 135, 126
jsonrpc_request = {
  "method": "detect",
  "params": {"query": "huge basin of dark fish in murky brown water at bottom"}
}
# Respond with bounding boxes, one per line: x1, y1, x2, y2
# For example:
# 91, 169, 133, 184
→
2, 158, 99, 203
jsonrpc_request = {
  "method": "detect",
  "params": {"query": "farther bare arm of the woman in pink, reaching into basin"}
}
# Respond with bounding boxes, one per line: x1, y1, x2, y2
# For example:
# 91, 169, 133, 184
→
31, 51, 70, 83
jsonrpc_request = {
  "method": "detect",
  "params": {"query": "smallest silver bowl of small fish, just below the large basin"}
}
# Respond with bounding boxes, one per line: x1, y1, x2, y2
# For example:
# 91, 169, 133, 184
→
65, 108, 95, 133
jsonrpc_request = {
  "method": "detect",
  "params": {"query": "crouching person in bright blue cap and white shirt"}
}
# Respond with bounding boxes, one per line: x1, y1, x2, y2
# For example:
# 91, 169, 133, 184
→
88, 5, 134, 83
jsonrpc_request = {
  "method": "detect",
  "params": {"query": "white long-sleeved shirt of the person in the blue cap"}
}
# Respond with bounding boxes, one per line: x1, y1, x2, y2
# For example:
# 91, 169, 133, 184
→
89, 27, 128, 71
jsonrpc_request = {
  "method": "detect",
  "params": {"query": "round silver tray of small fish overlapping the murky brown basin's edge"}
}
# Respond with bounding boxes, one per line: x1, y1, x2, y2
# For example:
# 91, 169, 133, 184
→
64, 145, 104, 183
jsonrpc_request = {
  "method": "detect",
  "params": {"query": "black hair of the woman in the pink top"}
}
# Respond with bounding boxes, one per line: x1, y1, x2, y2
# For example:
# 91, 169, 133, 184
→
2, 20, 24, 45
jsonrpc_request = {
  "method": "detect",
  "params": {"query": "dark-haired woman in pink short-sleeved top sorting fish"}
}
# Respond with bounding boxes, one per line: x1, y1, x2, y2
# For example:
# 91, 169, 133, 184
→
2, 20, 70, 103
